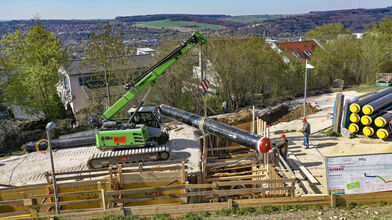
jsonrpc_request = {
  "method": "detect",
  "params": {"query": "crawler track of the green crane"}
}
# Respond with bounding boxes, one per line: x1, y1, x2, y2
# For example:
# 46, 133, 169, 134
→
87, 145, 170, 169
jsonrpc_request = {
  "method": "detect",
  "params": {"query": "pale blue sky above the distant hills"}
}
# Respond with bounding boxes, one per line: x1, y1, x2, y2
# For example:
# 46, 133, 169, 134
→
0, 0, 392, 20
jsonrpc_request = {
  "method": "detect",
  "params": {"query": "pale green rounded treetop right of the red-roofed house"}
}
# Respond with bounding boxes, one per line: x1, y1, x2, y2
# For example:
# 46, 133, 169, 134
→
305, 23, 351, 44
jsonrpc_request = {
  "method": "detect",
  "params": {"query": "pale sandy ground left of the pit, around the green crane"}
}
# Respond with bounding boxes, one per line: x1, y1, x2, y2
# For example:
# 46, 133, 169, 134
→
0, 125, 200, 186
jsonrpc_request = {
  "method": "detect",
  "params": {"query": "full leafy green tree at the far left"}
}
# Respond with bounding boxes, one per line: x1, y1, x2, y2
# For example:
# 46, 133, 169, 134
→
0, 19, 66, 120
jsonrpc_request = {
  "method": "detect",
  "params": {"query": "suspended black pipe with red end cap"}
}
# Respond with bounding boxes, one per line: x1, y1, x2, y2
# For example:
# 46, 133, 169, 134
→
159, 105, 271, 153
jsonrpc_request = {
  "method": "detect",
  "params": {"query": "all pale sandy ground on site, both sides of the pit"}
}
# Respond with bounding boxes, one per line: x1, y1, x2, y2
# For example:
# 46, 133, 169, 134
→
0, 88, 392, 193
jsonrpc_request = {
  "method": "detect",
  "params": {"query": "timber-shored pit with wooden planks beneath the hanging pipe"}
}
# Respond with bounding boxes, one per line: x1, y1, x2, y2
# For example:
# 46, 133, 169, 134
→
200, 114, 295, 202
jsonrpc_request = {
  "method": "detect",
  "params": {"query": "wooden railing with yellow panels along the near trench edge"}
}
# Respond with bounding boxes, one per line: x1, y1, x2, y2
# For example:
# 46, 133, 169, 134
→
0, 175, 294, 219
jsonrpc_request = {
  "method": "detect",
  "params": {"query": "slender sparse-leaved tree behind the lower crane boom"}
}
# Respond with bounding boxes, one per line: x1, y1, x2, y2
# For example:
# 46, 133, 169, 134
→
84, 22, 130, 108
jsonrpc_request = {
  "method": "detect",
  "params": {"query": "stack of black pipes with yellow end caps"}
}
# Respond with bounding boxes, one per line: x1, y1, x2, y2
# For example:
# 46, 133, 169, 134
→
349, 88, 392, 139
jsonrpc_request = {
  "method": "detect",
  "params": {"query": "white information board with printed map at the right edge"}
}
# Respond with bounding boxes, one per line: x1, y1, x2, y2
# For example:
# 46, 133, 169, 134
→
325, 154, 392, 194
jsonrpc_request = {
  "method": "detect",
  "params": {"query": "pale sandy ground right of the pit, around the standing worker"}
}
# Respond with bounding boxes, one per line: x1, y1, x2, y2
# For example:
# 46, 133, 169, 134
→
271, 91, 392, 193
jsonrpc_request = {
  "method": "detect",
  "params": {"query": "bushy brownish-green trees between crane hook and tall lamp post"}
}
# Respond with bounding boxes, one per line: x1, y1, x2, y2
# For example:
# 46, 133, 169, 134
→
208, 38, 287, 109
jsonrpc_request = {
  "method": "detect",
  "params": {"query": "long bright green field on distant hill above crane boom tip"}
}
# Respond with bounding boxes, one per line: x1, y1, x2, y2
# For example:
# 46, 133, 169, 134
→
136, 19, 222, 31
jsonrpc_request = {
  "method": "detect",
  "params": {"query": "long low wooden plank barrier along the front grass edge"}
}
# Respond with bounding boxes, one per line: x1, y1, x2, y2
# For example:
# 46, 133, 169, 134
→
0, 192, 392, 219
